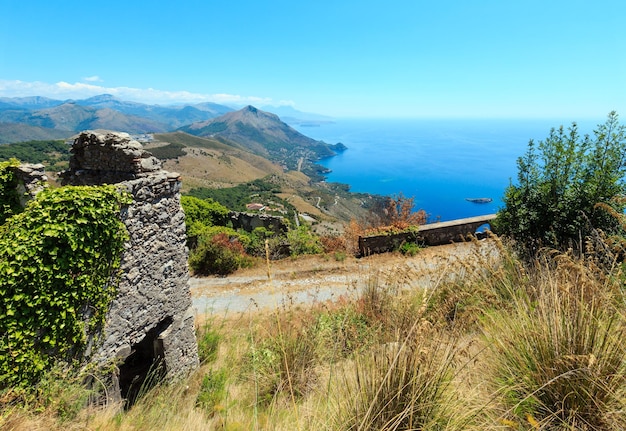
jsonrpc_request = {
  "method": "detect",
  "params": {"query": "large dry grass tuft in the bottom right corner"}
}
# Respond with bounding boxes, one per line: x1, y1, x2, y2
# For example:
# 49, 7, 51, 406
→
484, 251, 626, 430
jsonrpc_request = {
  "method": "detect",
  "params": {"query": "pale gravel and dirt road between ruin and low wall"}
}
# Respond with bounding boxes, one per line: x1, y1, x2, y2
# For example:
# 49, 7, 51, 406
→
190, 240, 496, 315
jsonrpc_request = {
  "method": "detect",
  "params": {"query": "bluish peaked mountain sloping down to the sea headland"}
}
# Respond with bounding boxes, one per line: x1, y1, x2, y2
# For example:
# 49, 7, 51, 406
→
180, 106, 344, 176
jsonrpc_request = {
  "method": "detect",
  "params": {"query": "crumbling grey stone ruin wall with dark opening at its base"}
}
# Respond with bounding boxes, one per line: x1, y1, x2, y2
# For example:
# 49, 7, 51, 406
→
54, 131, 199, 403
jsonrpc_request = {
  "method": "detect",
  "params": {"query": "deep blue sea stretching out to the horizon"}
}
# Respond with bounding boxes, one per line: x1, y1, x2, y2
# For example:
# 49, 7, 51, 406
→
296, 119, 598, 222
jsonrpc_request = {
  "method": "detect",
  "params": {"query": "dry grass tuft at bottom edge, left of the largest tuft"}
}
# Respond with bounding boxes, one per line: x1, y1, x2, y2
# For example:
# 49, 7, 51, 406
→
330, 322, 464, 431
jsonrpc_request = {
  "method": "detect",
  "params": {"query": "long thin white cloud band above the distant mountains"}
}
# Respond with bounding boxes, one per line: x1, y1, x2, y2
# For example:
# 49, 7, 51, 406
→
0, 76, 293, 106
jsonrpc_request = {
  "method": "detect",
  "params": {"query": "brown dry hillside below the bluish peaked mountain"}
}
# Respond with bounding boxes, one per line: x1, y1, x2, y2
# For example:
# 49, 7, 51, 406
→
145, 132, 376, 229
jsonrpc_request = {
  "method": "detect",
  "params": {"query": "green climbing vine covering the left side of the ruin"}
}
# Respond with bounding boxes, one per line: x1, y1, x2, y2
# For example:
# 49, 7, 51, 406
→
0, 186, 131, 388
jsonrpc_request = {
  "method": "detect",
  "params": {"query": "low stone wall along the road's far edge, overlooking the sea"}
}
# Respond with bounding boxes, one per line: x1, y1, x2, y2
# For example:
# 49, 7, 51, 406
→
359, 214, 496, 256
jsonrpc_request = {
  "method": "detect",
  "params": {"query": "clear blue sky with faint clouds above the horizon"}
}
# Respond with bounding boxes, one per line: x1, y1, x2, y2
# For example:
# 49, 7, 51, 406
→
0, 0, 626, 121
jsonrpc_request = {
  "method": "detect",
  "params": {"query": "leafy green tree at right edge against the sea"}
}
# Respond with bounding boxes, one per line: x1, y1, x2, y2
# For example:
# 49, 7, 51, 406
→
494, 112, 626, 256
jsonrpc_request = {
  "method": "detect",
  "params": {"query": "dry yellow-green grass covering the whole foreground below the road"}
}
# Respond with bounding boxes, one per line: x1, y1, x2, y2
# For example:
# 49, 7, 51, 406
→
0, 239, 626, 431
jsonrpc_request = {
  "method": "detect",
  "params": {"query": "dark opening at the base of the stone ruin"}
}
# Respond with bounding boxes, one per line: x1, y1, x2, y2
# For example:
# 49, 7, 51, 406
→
119, 317, 173, 408
